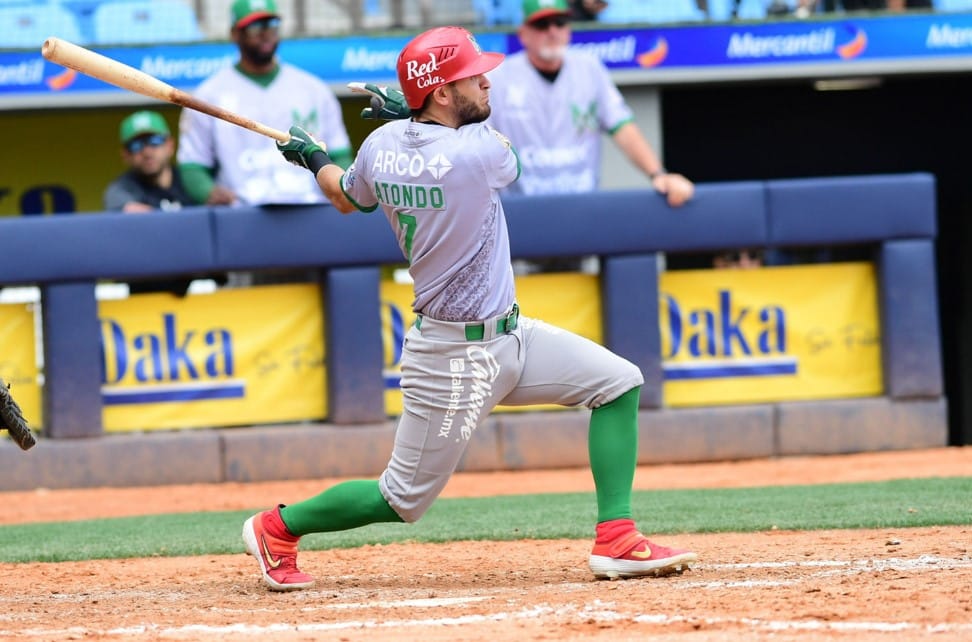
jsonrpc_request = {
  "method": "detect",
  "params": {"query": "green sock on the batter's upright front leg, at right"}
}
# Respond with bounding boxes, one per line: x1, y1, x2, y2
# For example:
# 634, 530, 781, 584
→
587, 386, 641, 523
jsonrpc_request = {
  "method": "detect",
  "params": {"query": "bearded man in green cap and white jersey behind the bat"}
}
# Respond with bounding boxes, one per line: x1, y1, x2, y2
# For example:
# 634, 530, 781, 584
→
178, 0, 351, 205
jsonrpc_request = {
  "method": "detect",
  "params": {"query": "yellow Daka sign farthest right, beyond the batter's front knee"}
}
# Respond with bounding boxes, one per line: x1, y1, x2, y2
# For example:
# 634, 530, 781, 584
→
660, 263, 882, 406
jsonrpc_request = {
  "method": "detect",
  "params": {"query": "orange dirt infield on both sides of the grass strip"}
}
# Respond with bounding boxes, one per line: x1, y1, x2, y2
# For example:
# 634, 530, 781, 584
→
0, 448, 972, 642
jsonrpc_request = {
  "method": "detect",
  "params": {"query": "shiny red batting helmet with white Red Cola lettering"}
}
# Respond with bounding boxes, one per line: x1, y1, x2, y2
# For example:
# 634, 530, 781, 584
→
398, 27, 504, 109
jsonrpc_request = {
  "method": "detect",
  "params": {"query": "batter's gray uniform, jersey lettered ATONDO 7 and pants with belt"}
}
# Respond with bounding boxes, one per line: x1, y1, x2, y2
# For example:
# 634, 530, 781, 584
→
341, 121, 643, 522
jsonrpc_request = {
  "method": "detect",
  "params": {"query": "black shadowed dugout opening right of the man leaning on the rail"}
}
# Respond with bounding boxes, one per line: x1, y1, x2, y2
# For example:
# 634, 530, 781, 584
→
660, 75, 972, 445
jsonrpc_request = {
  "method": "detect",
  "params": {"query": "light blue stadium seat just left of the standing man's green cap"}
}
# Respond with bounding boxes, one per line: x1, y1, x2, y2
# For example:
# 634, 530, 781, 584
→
92, 0, 203, 44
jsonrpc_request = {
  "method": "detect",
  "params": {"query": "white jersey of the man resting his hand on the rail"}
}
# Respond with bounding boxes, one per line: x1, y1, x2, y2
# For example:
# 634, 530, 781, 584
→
488, 48, 632, 194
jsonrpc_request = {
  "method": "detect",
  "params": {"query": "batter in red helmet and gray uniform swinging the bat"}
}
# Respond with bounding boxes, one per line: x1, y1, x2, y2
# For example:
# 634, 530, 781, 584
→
243, 27, 697, 591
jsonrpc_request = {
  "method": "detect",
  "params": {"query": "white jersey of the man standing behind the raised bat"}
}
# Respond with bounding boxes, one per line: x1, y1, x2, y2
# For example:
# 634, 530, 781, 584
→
177, 63, 351, 205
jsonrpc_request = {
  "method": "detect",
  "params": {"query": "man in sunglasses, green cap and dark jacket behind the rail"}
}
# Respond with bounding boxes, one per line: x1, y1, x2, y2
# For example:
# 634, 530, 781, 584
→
103, 111, 192, 212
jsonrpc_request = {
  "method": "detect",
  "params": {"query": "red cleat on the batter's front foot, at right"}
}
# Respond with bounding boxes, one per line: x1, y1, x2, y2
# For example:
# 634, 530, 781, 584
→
590, 520, 699, 580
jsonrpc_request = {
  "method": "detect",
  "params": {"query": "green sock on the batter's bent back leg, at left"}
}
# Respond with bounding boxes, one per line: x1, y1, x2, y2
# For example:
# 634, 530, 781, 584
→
280, 479, 405, 535
